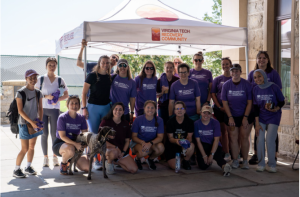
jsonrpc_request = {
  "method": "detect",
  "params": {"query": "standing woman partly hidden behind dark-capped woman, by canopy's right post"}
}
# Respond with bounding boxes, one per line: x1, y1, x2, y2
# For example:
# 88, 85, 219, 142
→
211, 57, 232, 160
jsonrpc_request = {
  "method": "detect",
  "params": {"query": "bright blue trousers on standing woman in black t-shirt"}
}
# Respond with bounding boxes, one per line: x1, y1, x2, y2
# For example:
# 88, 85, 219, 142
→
87, 103, 111, 134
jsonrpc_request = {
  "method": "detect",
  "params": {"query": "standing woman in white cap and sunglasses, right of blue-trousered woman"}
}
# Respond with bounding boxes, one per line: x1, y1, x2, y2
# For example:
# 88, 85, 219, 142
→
110, 59, 136, 123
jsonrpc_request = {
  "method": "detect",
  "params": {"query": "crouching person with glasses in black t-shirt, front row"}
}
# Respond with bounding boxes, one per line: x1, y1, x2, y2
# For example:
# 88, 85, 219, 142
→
165, 101, 195, 170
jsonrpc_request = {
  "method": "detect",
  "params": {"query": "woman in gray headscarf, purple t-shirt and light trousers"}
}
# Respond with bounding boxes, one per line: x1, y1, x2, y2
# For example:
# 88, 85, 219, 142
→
253, 69, 284, 172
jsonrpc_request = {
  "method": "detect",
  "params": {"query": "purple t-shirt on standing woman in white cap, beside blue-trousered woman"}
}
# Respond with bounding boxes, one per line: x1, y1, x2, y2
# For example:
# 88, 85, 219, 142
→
110, 75, 136, 115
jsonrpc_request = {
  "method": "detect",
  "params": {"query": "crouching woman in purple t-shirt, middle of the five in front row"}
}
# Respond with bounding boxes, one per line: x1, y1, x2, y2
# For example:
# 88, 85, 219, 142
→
130, 100, 165, 170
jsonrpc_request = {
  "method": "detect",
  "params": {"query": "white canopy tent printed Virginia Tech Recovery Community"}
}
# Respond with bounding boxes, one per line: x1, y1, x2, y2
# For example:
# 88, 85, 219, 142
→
56, 0, 248, 76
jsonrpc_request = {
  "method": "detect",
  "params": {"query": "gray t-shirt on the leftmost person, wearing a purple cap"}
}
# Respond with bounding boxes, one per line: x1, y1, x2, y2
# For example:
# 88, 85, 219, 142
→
16, 86, 43, 124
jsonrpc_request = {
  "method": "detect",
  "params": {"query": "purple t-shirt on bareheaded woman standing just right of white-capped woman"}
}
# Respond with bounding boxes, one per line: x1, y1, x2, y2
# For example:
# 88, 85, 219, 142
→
134, 76, 157, 116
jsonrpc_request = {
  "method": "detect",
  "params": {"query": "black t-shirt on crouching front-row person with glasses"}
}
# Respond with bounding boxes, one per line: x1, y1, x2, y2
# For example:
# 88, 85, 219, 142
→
166, 115, 194, 148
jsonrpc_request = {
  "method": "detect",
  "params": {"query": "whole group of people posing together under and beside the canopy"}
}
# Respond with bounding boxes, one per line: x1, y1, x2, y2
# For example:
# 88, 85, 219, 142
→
14, 40, 284, 177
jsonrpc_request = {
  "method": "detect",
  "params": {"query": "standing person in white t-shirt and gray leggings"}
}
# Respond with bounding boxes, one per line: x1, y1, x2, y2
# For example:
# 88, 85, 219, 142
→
35, 57, 69, 167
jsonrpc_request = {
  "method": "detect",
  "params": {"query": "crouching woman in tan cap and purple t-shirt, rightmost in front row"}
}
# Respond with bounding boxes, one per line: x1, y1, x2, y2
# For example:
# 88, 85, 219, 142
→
194, 105, 231, 176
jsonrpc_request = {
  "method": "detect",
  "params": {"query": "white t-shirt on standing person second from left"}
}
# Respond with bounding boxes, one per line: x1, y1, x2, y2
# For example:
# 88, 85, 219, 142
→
35, 74, 68, 109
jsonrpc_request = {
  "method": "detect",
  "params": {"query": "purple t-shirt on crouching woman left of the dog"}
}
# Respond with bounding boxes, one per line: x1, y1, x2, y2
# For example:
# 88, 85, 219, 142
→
56, 111, 87, 140
